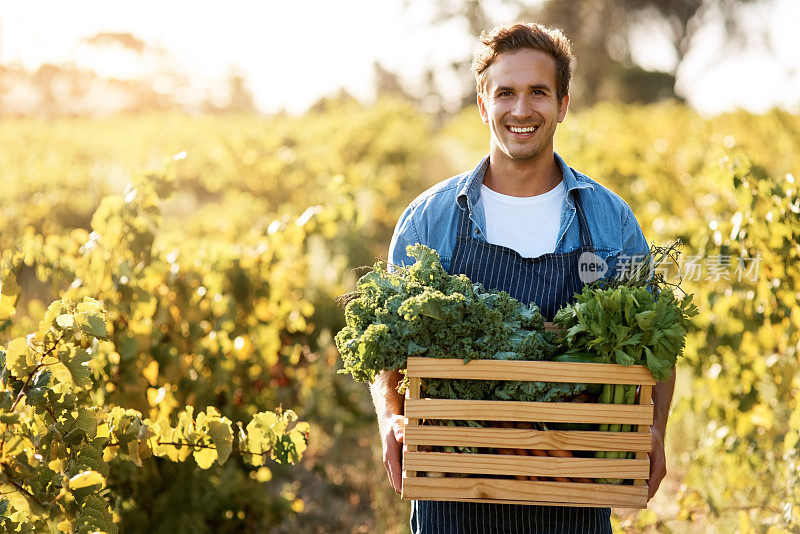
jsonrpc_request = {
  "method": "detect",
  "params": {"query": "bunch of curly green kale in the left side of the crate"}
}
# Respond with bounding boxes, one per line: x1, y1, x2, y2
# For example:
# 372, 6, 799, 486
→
336, 245, 585, 401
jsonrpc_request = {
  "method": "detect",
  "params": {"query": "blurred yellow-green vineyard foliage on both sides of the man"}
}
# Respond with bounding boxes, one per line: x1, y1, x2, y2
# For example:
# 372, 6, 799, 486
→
0, 99, 800, 532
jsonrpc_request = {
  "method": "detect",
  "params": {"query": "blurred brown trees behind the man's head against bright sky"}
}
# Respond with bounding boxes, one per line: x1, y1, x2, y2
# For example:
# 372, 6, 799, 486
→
406, 0, 773, 107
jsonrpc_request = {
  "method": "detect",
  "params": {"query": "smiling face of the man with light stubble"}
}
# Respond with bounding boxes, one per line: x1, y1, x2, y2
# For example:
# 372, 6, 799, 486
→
478, 49, 569, 161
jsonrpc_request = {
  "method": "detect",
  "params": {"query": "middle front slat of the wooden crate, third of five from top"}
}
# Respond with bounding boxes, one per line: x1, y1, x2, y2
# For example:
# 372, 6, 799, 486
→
405, 425, 652, 452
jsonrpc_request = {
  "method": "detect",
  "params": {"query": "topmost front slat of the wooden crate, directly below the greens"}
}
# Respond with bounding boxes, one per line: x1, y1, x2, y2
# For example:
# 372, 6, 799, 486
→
406, 357, 655, 385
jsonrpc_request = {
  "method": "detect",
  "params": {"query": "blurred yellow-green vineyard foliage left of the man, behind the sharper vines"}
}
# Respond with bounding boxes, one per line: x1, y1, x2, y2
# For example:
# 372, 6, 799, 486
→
0, 99, 427, 532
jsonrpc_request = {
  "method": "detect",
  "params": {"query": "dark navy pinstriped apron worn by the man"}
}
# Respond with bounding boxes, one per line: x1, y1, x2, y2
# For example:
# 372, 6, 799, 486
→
411, 190, 611, 534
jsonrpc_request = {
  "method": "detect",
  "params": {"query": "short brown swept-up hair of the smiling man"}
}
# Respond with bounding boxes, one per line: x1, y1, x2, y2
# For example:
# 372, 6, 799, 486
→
470, 22, 575, 102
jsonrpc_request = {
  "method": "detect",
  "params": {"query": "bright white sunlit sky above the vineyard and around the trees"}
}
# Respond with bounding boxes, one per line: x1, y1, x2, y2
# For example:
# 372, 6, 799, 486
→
0, 0, 800, 113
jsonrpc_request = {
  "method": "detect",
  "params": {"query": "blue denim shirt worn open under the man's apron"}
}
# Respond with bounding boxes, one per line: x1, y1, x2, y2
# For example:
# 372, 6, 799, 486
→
389, 154, 649, 270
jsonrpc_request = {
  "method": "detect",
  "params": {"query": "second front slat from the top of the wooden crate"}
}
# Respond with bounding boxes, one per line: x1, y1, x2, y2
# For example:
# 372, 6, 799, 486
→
405, 398, 653, 425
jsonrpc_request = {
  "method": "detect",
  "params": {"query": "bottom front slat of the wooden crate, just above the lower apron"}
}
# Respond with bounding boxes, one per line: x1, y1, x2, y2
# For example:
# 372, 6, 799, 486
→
403, 477, 647, 508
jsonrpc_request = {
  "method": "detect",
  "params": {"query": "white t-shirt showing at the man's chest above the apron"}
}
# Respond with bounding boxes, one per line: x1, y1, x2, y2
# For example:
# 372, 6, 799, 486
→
481, 180, 567, 258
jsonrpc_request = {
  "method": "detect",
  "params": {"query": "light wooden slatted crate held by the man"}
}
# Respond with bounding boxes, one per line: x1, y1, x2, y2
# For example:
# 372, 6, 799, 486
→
402, 357, 655, 508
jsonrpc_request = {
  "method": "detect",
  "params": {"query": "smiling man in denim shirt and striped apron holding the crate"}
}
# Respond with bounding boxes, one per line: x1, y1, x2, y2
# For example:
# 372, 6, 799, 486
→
371, 24, 674, 533
